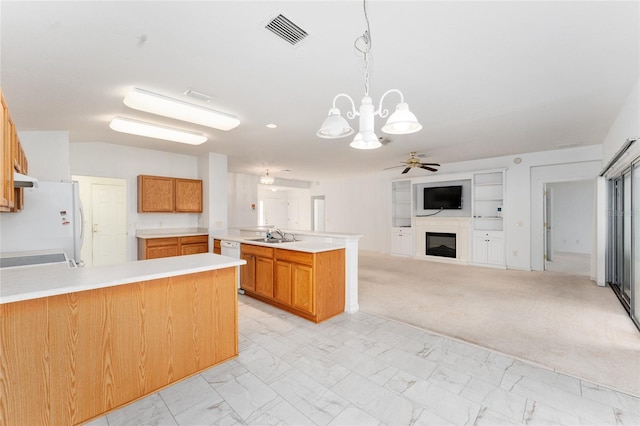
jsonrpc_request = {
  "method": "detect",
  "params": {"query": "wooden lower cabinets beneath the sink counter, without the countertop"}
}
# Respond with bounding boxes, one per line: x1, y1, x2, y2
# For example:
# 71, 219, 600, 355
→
240, 244, 345, 322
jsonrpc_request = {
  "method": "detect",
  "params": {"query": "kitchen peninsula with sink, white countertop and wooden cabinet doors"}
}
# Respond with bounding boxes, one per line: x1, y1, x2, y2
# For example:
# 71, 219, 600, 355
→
211, 227, 362, 322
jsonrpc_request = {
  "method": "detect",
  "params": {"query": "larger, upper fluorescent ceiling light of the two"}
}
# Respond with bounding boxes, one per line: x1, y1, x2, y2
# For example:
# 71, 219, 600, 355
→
124, 88, 240, 130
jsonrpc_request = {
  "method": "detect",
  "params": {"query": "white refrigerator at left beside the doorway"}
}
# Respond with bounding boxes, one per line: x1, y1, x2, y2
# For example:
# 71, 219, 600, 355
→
0, 181, 83, 265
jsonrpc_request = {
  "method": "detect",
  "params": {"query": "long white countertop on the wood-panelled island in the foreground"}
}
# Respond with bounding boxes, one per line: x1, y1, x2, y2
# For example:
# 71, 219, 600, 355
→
0, 253, 246, 304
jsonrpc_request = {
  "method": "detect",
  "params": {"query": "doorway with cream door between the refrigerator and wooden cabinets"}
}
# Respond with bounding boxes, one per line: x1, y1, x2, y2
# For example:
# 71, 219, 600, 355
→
72, 176, 127, 266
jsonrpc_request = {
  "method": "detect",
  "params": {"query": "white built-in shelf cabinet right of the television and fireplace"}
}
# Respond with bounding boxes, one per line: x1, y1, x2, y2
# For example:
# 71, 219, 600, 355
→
471, 170, 505, 267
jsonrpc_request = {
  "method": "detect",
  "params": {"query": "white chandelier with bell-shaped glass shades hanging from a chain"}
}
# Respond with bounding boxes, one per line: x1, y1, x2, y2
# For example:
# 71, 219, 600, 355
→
316, 0, 422, 149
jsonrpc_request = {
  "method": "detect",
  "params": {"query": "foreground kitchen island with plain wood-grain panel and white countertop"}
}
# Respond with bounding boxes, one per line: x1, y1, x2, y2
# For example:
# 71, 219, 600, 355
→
0, 253, 244, 425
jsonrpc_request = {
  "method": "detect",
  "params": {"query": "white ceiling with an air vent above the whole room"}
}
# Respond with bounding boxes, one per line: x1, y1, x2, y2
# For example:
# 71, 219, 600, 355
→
0, 0, 640, 180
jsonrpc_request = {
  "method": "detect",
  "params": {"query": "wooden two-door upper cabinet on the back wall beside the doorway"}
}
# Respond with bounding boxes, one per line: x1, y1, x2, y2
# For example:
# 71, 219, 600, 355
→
138, 175, 202, 213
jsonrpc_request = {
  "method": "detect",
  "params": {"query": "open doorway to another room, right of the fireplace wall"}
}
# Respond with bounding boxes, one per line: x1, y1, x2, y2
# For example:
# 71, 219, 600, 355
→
543, 180, 595, 276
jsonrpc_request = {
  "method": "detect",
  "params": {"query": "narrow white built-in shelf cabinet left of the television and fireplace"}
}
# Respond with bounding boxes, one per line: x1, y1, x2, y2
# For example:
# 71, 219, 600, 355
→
391, 180, 413, 256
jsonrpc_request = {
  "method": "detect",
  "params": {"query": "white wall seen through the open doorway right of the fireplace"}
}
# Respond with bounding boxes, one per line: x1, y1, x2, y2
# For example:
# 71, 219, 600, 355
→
547, 180, 595, 254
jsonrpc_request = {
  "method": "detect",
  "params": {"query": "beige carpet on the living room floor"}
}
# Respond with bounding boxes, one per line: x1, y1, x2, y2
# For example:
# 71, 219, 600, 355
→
359, 251, 640, 396
